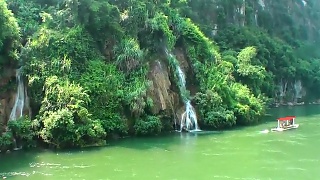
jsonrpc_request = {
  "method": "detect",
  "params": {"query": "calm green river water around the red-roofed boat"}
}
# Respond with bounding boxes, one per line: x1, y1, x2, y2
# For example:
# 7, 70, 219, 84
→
0, 105, 320, 180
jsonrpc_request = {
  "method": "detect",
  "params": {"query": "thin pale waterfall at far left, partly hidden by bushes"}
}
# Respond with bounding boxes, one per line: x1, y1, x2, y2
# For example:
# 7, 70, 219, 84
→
9, 68, 25, 120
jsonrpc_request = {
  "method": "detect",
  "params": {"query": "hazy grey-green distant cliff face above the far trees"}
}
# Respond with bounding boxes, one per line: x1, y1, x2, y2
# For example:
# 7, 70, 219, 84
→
205, 0, 319, 38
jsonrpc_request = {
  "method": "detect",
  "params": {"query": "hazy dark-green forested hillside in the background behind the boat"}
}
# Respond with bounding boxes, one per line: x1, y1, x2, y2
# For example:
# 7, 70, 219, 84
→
185, 0, 320, 103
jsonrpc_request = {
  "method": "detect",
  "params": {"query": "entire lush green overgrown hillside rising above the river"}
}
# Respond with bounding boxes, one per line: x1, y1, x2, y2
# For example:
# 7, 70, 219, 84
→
0, 0, 320, 150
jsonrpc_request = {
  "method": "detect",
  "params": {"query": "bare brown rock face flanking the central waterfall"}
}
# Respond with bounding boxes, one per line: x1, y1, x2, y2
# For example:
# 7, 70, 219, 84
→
148, 49, 194, 124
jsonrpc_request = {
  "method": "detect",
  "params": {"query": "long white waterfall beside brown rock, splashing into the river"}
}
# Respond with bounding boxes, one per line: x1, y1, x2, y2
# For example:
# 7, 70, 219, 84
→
165, 49, 200, 131
